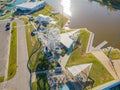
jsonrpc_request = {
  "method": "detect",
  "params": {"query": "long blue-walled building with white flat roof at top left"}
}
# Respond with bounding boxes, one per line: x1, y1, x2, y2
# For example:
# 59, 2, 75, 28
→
16, 1, 45, 15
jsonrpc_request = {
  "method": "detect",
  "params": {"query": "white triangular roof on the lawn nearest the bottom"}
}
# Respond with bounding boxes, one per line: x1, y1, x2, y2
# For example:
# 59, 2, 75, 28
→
68, 63, 92, 76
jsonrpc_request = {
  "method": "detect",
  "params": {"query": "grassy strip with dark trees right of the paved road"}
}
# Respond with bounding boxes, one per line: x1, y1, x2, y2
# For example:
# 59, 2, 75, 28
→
21, 18, 53, 72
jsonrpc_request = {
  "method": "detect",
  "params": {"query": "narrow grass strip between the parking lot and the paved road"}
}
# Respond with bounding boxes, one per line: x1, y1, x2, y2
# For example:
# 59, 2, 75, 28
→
8, 22, 17, 79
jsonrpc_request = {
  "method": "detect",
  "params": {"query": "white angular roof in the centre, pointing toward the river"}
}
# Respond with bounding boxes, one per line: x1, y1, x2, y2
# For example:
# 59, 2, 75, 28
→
60, 30, 79, 48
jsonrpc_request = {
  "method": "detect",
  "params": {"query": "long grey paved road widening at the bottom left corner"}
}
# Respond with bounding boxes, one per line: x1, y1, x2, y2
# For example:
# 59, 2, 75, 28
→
0, 20, 30, 90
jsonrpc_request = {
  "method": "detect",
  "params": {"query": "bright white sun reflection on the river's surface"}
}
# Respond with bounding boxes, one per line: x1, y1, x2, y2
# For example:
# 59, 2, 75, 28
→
61, 0, 72, 16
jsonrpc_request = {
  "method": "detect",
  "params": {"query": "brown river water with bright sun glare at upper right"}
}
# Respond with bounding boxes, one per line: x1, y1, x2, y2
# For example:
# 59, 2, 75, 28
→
45, 0, 120, 48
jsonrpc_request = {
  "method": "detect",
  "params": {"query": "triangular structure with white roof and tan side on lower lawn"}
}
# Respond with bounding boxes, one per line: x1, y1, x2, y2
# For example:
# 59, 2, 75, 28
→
68, 63, 92, 85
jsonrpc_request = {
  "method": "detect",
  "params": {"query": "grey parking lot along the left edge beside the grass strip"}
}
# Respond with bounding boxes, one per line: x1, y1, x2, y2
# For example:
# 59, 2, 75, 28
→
0, 20, 10, 76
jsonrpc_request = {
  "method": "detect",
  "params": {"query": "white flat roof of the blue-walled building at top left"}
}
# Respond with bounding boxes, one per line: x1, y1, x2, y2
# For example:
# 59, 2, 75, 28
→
17, 1, 44, 9
